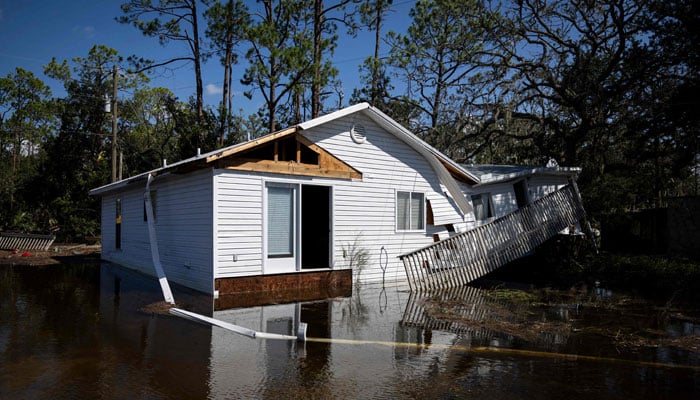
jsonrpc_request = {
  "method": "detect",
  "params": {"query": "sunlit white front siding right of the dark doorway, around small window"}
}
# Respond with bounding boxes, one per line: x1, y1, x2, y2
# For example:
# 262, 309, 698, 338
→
302, 115, 442, 282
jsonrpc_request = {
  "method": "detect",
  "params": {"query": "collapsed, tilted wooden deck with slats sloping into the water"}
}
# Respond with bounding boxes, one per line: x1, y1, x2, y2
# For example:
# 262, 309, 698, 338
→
399, 182, 586, 290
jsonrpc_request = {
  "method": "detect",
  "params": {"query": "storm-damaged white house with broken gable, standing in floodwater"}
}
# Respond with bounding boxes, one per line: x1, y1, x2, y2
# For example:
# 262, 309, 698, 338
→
90, 103, 578, 294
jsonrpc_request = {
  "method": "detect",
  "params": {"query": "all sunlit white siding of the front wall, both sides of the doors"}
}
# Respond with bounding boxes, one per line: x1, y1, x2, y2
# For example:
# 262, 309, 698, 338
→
214, 115, 443, 282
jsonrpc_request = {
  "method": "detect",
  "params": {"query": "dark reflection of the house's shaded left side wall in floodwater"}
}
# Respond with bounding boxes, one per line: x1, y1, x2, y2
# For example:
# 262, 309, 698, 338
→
98, 263, 212, 398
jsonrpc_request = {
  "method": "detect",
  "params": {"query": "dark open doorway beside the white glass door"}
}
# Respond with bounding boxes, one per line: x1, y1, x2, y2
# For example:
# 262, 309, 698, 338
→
301, 185, 331, 269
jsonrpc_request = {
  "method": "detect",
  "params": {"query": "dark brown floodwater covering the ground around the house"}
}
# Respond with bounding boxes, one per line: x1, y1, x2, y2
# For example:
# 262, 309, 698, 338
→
0, 264, 700, 399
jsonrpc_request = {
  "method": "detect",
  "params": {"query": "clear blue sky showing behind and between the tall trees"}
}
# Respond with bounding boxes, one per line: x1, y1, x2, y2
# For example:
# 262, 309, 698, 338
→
0, 0, 415, 112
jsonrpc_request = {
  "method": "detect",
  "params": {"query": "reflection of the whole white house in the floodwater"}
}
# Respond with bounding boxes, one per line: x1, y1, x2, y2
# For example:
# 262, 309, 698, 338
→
100, 264, 556, 398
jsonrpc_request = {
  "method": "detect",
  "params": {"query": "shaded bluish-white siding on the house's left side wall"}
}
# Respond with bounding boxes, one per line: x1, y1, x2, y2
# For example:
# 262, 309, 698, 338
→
102, 170, 214, 293
